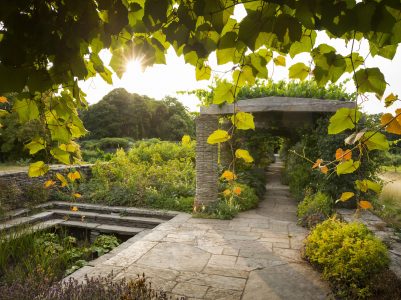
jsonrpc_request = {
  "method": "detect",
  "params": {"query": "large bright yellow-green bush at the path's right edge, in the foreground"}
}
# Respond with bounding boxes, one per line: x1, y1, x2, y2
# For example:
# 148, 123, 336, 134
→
305, 218, 389, 298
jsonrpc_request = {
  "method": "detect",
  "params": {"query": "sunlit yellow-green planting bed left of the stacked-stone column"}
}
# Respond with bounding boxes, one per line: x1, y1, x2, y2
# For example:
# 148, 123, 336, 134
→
81, 140, 195, 212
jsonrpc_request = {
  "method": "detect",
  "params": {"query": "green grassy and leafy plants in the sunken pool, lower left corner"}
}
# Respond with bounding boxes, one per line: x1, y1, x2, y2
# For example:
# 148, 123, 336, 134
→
0, 227, 119, 299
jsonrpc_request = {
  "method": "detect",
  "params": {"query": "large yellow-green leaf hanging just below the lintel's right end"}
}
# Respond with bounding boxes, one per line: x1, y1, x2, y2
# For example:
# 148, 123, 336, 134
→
328, 107, 362, 134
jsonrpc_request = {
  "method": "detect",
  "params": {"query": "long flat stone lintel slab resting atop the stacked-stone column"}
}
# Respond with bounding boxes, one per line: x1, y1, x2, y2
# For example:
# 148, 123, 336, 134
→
200, 96, 355, 115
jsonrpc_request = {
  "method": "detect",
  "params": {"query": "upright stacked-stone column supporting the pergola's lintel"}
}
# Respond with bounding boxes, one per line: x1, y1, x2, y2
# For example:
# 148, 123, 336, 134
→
194, 115, 218, 207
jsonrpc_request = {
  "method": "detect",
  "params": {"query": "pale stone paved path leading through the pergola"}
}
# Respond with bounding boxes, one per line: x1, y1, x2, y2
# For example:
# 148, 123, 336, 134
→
72, 162, 330, 300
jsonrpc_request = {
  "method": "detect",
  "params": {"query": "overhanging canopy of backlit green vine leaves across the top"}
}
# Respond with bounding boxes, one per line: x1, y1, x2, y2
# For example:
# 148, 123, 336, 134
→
0, 0, 401, 175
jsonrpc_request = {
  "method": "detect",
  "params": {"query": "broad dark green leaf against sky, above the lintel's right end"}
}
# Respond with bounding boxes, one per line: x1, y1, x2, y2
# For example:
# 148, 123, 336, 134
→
354, 68, 386, 99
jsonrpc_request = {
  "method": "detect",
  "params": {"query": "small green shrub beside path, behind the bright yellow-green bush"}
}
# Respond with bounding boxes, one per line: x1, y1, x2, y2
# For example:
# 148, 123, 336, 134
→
297, 191, 333, 227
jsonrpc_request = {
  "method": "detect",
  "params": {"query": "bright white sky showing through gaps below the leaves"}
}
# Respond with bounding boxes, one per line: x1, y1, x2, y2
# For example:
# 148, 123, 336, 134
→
80, 7, 401, 113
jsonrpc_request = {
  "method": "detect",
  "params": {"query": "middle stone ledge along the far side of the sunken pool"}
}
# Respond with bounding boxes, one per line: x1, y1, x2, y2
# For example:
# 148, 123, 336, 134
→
51, 209, 166, 228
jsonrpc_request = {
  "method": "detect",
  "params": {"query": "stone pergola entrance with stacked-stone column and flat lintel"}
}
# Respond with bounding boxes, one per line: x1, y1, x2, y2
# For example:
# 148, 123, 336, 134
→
195, 97, 355, 206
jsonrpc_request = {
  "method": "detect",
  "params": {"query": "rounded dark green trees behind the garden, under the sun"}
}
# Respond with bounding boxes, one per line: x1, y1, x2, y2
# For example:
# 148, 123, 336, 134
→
82, 88, 195, 141
